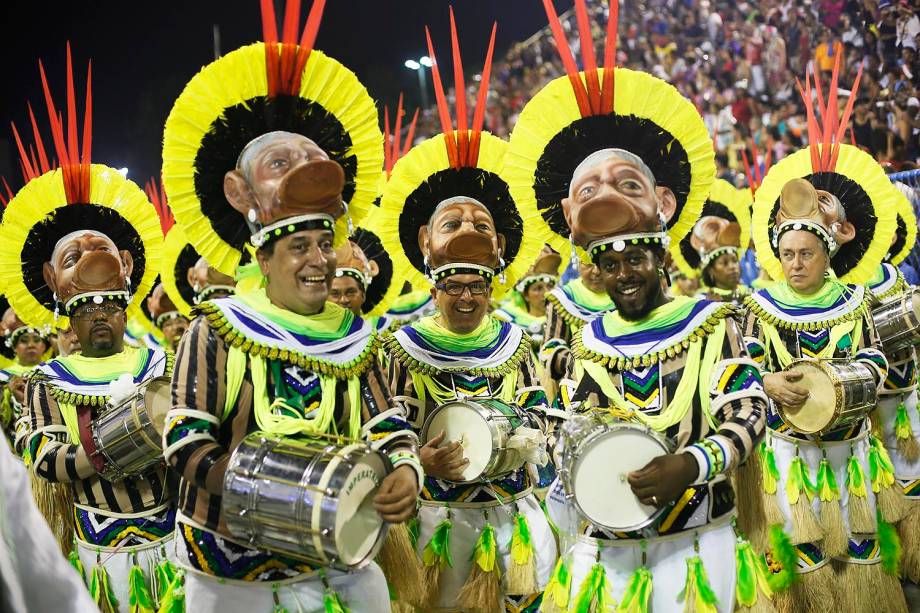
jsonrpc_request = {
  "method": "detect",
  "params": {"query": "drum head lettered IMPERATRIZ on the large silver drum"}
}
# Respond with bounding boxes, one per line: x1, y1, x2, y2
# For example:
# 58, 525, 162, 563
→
335, 453, 386, 566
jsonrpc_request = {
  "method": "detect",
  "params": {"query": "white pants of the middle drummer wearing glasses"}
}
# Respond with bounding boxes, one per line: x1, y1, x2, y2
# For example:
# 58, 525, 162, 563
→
418, 494, 556, 609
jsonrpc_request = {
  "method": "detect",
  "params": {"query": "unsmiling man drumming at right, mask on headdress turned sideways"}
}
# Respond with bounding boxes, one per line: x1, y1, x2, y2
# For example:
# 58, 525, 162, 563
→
745, 69, 906, 611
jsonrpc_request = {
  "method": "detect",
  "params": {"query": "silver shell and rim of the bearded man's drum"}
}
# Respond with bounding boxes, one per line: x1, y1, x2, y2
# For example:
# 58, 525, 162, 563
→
558, 415, 674, 532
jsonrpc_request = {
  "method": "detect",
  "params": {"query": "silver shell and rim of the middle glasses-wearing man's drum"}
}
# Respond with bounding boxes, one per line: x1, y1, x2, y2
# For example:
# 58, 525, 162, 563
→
420, 398, 524, 483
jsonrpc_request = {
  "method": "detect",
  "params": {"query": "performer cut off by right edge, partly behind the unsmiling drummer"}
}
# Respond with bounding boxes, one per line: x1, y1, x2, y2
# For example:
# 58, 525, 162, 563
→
866, 187, 920, 583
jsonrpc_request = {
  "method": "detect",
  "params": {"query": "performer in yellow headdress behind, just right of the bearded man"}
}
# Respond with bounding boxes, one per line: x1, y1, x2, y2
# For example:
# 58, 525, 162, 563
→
671, 179, 751, 304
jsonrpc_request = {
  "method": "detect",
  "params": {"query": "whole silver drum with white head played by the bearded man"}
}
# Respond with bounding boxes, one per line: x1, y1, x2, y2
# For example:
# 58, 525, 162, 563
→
559, 415, 672, 532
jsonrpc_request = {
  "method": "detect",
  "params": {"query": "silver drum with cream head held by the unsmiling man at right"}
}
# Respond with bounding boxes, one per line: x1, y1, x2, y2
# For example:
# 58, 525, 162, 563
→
777, 360, 878, 434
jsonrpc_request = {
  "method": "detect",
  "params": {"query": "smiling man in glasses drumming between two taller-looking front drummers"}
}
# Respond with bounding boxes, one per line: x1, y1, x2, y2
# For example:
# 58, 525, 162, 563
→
381, 14, 556, 611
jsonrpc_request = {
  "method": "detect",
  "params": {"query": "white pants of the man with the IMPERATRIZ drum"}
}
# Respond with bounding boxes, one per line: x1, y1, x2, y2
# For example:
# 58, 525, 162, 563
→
185, 563, 390, 613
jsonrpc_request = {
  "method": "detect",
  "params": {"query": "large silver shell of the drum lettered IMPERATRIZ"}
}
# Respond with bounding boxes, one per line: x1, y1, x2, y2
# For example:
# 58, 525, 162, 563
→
222, 432, 391, 570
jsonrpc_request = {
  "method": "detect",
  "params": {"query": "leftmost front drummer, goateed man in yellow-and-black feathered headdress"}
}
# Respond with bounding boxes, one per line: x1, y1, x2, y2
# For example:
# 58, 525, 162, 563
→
0, 49, 175, 612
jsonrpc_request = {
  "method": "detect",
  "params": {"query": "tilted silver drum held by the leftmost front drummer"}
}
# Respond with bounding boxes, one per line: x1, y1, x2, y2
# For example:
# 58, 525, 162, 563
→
90, 377, 172, 481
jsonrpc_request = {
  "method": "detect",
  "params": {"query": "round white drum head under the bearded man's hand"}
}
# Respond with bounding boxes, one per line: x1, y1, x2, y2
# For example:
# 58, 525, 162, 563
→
572, 425, 668, 530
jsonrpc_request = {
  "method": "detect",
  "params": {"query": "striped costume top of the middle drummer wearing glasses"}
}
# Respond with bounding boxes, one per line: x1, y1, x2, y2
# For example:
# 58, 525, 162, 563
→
384, 316, 546, 505
